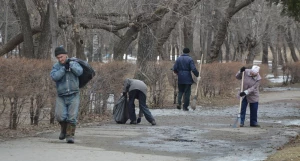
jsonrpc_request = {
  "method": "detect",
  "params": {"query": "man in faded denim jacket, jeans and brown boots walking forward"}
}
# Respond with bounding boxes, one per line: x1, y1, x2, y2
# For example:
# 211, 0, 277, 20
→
50, 47, 83, 143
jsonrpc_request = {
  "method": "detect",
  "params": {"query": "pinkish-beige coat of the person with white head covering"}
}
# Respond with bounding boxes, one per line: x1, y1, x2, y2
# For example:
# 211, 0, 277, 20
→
235, 69, 261, 103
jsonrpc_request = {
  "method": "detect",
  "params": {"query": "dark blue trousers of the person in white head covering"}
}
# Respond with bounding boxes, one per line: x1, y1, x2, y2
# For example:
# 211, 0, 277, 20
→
241, 96, 258, 126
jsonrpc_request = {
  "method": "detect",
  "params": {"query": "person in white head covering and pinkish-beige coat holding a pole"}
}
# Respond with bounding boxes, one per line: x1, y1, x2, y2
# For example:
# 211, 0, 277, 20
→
236, 65, 261, 127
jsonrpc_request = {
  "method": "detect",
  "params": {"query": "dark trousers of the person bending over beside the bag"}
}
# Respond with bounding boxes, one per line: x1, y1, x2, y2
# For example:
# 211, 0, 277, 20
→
128, 89, 154, 123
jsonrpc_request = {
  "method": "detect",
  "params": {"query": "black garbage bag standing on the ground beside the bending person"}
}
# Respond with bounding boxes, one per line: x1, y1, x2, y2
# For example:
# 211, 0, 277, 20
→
113, 96, 129, 124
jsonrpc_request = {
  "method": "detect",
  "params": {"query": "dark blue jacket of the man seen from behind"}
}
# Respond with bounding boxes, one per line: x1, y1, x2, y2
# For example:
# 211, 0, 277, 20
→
173, 53, 199, 84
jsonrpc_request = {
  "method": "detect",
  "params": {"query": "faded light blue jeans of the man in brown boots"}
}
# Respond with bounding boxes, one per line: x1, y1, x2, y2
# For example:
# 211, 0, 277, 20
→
55, 92, 80, 125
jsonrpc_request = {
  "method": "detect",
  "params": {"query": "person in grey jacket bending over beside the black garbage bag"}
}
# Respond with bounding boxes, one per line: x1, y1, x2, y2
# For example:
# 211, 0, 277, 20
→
123, 78, 156, 125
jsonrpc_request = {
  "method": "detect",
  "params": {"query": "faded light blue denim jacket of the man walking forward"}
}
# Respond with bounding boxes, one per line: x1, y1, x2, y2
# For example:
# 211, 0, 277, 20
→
50, 61, 83, 96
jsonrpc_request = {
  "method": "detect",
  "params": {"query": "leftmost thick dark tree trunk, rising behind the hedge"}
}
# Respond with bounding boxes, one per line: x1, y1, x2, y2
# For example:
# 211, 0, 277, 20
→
16, 0, 34, 58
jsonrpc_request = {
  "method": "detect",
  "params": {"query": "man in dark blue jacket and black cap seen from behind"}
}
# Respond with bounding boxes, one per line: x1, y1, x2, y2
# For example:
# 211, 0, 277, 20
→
173, 48, 200, 111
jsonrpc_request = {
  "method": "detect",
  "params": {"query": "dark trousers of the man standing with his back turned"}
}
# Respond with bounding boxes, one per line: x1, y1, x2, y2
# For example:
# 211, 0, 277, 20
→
178, 84, 192, 109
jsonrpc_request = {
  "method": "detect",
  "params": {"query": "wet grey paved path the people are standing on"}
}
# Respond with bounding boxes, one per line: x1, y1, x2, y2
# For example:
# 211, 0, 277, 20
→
0, 89, 300, 161
